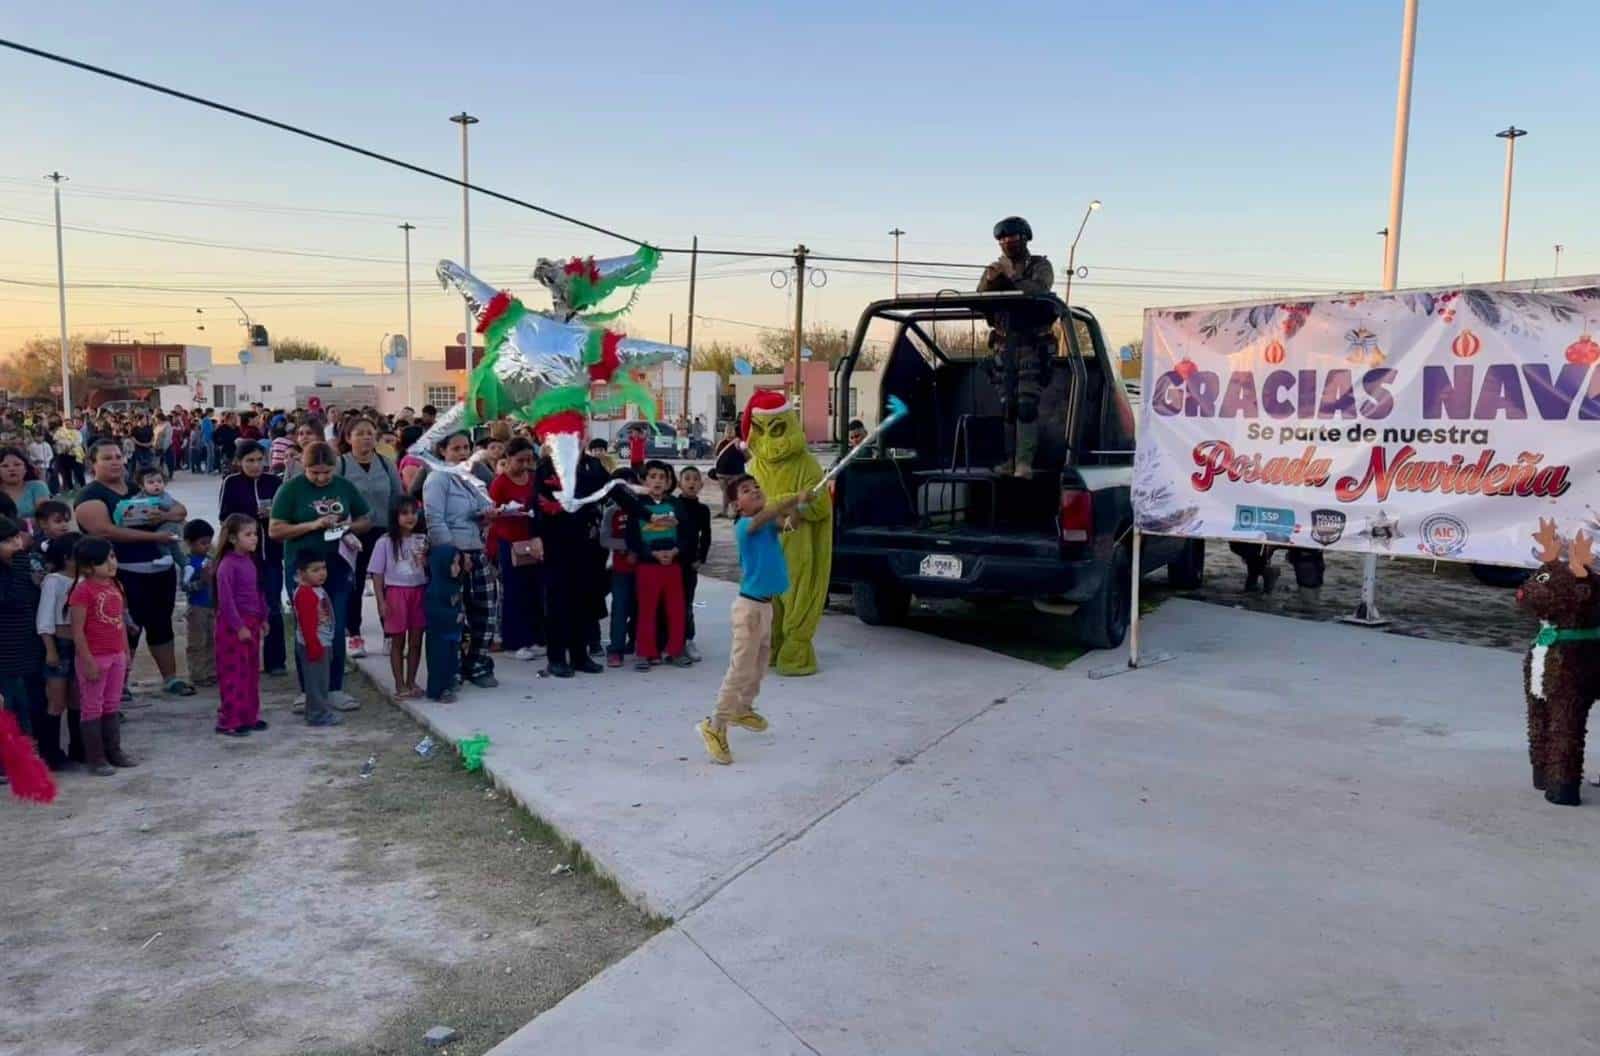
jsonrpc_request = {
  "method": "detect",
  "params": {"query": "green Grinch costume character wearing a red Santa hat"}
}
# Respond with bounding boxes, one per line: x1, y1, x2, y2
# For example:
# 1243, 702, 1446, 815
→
742, 389, 834, 675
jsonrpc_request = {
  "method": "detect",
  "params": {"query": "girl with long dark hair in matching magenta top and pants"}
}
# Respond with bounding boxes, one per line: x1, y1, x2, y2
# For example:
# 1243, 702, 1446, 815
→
214, 514, 267, 738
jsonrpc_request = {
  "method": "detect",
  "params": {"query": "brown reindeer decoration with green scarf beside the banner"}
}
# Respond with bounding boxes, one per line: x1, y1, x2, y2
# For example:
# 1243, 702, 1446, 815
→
1517, 517, 1600, 806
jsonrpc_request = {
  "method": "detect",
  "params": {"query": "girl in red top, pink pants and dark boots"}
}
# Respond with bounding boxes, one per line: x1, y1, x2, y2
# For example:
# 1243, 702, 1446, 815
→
67, 538, 136, 778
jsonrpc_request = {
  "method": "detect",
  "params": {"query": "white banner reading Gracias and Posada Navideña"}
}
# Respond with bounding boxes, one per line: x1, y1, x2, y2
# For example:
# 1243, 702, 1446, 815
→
1133, 277, 1600, 565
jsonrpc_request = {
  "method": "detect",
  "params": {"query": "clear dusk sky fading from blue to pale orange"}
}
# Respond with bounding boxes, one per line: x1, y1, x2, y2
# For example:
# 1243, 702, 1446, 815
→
0, 0, 1600, 368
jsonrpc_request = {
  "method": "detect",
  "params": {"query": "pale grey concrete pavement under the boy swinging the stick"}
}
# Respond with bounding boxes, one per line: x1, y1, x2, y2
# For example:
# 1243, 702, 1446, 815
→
165, 480, 1600, 1056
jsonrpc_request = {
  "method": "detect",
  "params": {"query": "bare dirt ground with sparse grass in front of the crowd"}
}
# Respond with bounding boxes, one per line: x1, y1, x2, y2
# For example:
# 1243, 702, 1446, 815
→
0, 611, 659, 1056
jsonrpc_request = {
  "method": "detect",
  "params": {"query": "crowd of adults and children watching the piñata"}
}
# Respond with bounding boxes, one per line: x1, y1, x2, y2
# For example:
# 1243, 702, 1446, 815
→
0, 396, 776, 774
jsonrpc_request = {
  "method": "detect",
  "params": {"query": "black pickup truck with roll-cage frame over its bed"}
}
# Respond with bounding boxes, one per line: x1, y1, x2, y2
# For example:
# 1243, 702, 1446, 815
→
834, 291, 1205, 648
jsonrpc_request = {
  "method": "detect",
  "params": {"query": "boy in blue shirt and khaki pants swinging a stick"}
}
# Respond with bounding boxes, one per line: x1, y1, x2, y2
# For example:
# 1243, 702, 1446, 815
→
694, 475, 811, 765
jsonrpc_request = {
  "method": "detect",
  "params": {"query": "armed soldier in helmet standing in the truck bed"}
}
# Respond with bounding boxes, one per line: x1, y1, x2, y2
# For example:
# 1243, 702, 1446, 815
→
978, 216, 1056, 480
